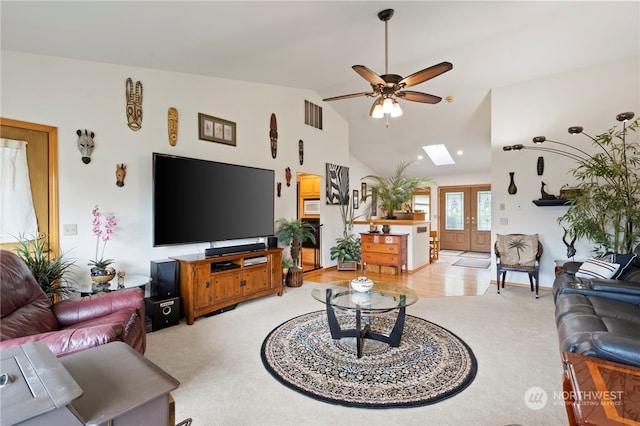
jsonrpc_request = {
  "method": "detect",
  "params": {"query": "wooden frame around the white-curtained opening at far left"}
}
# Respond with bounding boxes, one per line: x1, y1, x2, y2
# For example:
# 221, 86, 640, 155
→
0, 117, 60, 256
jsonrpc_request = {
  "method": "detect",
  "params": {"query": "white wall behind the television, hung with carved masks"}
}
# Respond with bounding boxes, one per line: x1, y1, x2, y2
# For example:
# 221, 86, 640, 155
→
1, 51, 352, 282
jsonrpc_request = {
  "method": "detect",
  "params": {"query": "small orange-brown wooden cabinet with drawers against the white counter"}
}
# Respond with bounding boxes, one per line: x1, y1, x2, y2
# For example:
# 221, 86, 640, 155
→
360, 233, 409, 274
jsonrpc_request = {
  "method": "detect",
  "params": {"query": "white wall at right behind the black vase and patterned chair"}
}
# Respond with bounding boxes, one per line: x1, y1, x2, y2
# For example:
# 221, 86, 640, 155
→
491, 57, 640, 287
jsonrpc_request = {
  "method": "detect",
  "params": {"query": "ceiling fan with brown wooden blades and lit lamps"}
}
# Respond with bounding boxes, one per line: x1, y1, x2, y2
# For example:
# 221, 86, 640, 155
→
323, 9, 453, 118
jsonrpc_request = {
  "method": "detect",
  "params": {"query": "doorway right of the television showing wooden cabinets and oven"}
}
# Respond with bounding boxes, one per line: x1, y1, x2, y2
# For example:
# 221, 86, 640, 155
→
296, 173, 322, 272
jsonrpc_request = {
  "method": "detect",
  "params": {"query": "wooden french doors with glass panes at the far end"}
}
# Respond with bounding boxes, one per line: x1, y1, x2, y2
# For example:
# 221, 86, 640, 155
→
438, 185, 491, 252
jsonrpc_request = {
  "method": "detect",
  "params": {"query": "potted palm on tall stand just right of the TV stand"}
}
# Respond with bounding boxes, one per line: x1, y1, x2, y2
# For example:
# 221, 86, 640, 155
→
276, 217, 316, 287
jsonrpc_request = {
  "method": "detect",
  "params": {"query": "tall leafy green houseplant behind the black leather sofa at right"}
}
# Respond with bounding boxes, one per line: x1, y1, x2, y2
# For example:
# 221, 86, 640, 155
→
558, 113, 640, 253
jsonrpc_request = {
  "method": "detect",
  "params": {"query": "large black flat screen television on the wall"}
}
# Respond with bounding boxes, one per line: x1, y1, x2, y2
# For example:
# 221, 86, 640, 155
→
153, 153, 275, 247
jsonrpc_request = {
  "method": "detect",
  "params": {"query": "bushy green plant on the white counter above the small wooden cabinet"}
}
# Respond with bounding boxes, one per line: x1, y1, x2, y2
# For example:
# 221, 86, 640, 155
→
362, 162, 430, 219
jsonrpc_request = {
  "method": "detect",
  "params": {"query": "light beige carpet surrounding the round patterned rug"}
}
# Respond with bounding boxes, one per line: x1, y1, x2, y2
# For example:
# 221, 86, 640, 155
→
146, 282, 567, 426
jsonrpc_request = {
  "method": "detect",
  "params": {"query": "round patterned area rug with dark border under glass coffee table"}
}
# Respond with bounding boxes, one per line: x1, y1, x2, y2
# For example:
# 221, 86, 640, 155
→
261, 311, 477, 408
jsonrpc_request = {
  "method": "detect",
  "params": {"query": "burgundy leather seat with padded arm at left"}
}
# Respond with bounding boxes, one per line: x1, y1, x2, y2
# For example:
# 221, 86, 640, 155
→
0, 250, 146, 357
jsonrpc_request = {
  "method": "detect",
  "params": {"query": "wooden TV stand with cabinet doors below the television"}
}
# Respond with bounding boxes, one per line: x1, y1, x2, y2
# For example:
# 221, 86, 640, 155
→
171, 248, 283, 325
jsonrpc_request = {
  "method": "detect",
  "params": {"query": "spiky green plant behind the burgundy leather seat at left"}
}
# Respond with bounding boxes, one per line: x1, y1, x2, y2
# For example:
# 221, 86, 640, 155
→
15, 235, 76, 301
